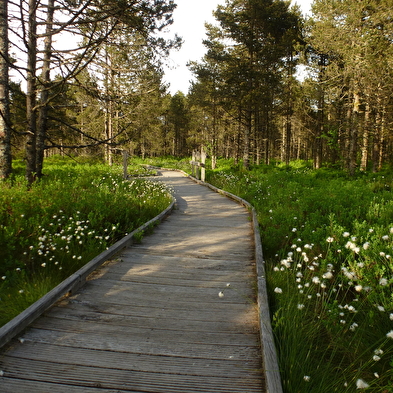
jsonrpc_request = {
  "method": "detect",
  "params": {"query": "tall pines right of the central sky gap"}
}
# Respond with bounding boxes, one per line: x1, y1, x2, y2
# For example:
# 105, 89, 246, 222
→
189, 0, 393, 174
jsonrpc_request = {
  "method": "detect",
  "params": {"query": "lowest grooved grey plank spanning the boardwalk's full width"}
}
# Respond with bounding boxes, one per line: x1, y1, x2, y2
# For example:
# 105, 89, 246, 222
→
0, 359, 262, 393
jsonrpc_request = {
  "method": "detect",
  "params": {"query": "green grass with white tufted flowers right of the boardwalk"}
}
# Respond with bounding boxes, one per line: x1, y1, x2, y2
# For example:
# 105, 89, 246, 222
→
151, 156, 393, 393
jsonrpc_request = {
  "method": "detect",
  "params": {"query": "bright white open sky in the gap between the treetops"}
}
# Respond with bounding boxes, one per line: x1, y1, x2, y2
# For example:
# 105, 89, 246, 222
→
164, 0, 312, 95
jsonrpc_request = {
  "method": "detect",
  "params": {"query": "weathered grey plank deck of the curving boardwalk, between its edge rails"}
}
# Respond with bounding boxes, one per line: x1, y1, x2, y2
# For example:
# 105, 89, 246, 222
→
0, 171, 266, 393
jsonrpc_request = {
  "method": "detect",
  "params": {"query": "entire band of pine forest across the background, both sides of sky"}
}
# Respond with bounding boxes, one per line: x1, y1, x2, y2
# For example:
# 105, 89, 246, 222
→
0, 0, 393, 182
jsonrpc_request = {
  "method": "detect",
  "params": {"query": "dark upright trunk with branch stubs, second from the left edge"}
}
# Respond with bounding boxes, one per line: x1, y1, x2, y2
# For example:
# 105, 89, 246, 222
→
26, 0, 37, 184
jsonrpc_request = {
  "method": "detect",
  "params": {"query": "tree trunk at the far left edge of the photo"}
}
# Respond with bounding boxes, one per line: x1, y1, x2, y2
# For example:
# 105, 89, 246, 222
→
0, 0, 12, 178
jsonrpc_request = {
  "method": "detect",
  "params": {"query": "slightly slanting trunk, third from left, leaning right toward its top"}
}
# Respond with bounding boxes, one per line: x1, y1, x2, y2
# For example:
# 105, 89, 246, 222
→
36, 0, 55, 178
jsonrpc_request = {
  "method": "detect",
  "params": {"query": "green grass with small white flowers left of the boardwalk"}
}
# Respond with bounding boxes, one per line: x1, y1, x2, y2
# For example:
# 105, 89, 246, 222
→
0, 158, 170, 325
